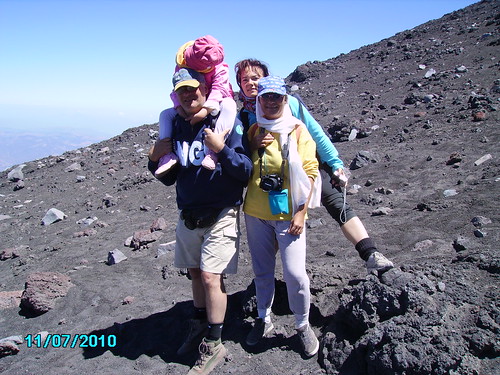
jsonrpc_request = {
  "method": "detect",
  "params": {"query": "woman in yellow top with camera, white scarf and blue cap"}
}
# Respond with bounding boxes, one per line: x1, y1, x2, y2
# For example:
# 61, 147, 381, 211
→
243, 76, 321, 356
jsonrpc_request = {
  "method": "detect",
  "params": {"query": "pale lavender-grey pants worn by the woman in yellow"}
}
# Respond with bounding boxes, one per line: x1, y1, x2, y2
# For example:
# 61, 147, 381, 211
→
245, 214, 311, 328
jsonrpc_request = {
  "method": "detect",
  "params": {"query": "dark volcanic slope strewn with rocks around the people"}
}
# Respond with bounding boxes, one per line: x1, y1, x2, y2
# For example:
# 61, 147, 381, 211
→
0, 1, 500, 375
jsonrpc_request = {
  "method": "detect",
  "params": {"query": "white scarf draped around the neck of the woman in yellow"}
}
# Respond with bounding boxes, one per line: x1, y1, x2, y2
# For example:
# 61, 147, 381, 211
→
256, 98, 321, 215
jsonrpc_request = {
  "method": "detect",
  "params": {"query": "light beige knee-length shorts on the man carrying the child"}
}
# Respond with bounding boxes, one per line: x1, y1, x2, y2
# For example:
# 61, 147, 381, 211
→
174, 207, 240, 274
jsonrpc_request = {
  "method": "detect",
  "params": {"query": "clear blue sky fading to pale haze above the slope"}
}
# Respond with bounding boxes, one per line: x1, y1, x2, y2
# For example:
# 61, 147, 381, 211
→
0, 0, 477, 139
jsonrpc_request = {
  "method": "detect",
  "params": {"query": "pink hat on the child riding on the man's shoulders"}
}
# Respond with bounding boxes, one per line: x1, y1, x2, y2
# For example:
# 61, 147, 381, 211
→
184, 35, 224, 72
